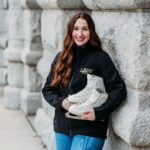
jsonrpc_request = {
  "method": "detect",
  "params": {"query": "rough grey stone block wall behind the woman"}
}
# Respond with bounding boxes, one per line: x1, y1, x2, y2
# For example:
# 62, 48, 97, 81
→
0, 0, 150, 150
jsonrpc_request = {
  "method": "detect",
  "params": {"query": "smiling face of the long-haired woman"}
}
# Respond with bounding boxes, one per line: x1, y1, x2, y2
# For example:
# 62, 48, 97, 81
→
72, 18, 90, 46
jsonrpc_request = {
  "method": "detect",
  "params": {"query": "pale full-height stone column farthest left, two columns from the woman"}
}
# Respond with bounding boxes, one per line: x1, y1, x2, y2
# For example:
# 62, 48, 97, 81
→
4, 0, 24, 109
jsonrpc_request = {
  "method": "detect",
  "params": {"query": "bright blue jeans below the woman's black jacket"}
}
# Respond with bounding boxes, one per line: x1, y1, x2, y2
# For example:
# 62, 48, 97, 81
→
55, 132, 105, 150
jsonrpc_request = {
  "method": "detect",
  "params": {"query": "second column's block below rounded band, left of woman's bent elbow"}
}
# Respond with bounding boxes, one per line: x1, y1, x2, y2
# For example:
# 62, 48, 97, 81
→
24, 65, 42, 92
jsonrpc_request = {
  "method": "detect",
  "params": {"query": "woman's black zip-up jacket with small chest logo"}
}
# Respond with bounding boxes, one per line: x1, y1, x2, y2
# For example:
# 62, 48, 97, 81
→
42, 44, 126, 138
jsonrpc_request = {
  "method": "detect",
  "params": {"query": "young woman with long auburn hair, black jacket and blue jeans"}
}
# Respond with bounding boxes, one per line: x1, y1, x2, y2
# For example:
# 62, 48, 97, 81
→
42, 12, 126, 150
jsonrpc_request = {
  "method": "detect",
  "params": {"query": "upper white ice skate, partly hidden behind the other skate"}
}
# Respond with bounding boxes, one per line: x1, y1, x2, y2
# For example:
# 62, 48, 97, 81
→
68, 74, 105, 103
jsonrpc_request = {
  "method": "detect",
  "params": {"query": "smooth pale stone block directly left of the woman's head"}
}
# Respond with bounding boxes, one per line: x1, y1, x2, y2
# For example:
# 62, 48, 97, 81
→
41, 10, 77, 50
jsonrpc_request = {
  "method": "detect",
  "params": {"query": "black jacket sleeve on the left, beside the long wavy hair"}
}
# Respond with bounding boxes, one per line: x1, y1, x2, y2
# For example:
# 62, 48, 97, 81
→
42, 53, 66, 111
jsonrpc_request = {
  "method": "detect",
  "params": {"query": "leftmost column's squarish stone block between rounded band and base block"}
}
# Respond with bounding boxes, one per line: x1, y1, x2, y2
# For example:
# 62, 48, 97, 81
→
8, 62, 24, 87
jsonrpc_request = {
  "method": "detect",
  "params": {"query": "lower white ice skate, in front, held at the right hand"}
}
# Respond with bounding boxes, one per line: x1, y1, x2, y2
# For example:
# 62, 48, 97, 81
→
66, 89, 108, 119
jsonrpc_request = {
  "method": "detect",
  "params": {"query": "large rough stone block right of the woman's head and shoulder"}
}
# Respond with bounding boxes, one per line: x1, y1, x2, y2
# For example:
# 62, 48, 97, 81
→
92, 11, 150, 90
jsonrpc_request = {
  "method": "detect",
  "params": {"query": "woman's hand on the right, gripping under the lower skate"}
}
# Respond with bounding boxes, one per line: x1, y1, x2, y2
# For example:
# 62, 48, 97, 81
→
81, 109, 96, 121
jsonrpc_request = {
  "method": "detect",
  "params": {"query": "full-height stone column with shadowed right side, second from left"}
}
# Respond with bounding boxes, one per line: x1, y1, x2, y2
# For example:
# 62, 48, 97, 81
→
21, 0, 42, 115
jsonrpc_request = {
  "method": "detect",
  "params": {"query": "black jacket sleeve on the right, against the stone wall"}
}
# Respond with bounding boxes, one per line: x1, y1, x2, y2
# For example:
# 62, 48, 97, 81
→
94, 53, 126, 120
